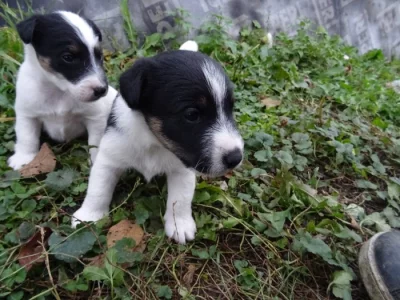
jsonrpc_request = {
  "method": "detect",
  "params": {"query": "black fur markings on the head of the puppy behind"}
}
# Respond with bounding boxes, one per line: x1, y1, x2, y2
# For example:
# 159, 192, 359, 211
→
17, 12, 106, 83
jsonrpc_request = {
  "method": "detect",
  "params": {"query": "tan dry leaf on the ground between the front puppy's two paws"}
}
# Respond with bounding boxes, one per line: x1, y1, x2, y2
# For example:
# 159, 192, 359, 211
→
107, 220, 144, 251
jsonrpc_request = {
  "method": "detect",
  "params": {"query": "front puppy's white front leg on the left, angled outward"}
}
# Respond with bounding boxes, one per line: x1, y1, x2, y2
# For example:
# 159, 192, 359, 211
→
72, 151, 123, 227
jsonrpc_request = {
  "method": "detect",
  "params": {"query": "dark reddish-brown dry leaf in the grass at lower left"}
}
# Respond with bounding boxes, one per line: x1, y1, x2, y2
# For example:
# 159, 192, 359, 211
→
18, 227, 51, 271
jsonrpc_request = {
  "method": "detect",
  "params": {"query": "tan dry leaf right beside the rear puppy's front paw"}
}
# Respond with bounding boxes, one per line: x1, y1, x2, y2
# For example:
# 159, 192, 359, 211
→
20, 143, 56, 177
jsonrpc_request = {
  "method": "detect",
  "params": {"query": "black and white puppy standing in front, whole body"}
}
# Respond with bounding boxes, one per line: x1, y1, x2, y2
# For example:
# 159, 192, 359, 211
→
73, 41, 243, 243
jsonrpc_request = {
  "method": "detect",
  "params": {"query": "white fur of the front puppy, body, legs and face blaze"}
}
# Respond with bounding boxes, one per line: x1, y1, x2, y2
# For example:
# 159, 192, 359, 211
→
72, 42, 243, 244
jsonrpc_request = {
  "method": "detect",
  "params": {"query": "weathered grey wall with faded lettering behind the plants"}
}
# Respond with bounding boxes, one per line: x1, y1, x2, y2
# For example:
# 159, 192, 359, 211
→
3, 0, 400, 57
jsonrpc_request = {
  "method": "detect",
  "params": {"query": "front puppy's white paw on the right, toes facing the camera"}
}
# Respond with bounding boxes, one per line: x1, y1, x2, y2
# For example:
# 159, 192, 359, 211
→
164, 213, 196, 244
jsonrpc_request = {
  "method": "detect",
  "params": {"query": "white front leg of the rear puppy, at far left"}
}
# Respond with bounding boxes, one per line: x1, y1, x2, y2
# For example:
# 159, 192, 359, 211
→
8, 116, 41, 170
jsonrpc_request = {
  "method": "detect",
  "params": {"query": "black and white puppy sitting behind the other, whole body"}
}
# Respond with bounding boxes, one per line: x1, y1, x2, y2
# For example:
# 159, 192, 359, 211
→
8, 11, 117, 169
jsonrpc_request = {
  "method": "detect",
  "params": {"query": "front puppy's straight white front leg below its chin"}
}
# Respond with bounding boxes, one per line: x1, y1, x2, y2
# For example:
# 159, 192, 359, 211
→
164, 169, 196, 244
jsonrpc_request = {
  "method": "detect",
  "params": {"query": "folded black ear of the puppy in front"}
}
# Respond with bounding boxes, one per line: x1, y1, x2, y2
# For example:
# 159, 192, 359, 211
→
119, 58, 151, 109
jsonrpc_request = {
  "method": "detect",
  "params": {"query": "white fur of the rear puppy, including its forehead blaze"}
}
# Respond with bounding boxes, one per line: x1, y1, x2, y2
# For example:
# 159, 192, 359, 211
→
8, 12, 117, 170
